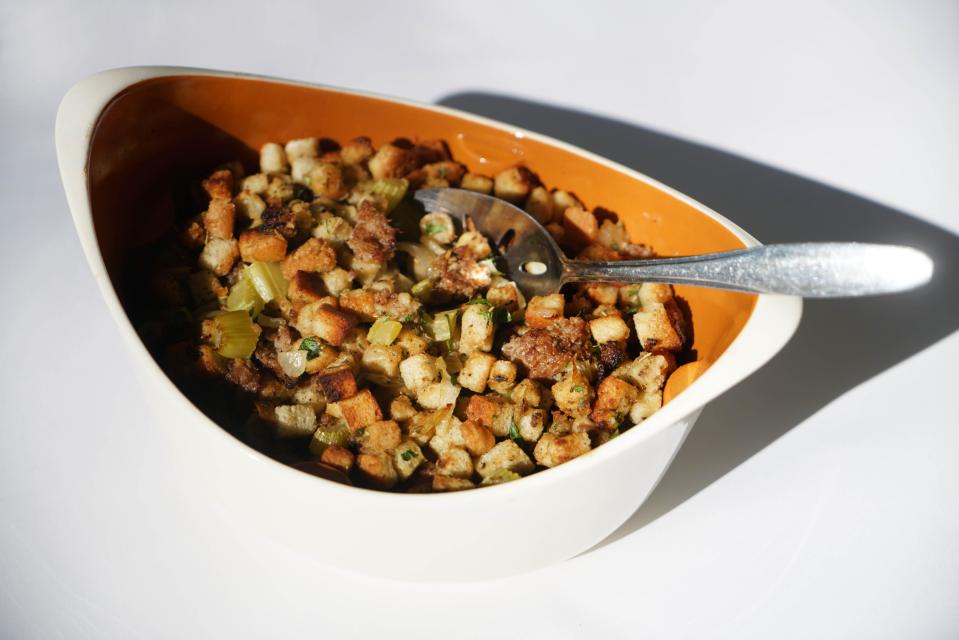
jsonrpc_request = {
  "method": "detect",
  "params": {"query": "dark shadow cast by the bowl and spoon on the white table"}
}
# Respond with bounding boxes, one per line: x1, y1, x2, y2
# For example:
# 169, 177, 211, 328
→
440, 93, 959, 546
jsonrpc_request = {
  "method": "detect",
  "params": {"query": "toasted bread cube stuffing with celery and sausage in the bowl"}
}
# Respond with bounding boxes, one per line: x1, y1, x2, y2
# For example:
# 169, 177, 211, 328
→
150, 134, 695, 492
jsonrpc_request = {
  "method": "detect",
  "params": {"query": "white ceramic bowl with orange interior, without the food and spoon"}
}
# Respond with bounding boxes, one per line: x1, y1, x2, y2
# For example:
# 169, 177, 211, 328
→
56, 67, 801, 580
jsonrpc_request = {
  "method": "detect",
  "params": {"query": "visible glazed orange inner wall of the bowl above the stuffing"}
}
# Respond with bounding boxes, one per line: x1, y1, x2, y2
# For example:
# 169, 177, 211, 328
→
87, 76, 756, 399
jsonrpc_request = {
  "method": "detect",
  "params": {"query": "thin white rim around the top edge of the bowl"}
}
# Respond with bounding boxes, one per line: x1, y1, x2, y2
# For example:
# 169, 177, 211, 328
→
55, 66, 802, 506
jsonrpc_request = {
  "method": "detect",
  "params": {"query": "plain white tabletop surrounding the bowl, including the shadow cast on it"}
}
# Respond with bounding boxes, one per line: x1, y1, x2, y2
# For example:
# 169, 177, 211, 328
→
0, 0, 959, 638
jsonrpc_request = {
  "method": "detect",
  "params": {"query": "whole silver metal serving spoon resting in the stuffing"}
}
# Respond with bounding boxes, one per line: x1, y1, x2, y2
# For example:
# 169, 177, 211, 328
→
414, 189, 933, 298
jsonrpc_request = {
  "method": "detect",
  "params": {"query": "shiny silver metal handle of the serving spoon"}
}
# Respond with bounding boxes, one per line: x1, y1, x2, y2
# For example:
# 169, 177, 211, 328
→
562, 242, 933, 298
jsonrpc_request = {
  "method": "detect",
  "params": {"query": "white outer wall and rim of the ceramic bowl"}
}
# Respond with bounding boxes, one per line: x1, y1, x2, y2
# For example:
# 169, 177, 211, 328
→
56, 67, 801, 580
